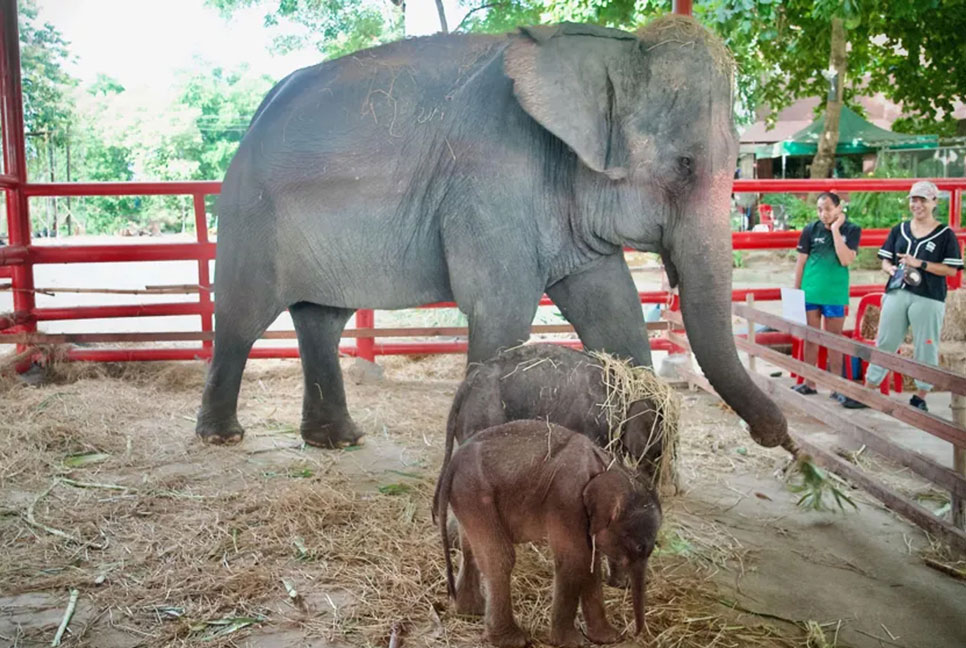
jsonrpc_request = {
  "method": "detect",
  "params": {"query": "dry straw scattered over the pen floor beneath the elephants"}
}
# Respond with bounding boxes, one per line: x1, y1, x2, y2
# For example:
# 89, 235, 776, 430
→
0, 358, 816, 648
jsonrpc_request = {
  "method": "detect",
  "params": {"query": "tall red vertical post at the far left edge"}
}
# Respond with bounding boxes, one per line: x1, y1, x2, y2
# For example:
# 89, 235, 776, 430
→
0, 0, 37, 350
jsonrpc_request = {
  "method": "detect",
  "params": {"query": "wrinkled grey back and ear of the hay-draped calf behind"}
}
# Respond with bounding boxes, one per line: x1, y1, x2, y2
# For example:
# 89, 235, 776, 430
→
443, 343, 663, 480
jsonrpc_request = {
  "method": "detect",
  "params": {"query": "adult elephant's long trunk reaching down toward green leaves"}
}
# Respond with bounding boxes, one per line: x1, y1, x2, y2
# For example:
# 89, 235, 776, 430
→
670, 174, 795, 453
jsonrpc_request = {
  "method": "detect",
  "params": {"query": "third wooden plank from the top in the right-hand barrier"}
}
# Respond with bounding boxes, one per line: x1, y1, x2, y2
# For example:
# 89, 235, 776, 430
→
751, 373, 966, 498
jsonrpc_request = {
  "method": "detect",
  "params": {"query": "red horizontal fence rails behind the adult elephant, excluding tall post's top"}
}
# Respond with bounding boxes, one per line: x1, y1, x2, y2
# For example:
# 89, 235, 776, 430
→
0, 178, 966, 361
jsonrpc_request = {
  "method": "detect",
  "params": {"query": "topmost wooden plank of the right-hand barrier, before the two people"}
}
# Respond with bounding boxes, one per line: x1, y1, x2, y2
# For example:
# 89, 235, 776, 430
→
732, 304, 966, 394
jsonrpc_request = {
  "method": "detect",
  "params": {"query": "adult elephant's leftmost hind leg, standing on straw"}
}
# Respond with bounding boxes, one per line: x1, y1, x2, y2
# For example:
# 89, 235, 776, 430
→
195, 290, 283, 444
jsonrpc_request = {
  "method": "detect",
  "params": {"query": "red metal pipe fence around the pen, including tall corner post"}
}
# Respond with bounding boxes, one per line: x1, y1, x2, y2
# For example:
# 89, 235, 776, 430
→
0, 0, 966, 361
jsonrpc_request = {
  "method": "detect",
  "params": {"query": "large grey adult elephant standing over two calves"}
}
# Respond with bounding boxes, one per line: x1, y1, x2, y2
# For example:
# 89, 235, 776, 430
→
197, 16, 787, 446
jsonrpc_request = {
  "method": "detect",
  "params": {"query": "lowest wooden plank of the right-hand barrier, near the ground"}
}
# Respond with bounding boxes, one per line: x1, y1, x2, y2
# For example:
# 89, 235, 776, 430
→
789, 430, 966, 551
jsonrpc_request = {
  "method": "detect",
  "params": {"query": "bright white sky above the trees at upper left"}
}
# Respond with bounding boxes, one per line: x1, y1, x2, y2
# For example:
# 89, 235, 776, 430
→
38, 0, 464, 90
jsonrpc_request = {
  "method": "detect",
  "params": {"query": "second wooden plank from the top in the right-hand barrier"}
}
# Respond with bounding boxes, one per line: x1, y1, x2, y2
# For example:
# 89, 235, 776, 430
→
735, 338, 966, 448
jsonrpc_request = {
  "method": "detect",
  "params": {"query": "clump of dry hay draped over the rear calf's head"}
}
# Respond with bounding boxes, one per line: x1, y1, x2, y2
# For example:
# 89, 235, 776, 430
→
591, 352, 681, 497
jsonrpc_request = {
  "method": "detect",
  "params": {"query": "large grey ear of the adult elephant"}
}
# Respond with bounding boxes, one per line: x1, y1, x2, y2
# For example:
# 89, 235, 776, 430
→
503, 23, 637, 180
